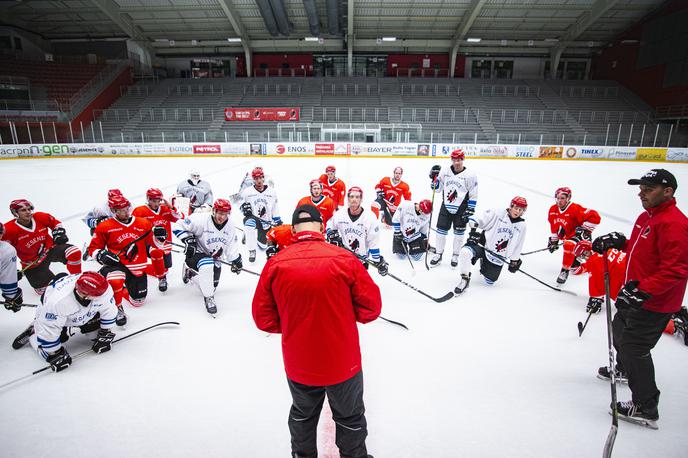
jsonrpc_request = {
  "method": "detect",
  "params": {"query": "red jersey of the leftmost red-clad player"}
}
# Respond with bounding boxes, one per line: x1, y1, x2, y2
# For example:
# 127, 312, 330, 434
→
2, 212, 61, 268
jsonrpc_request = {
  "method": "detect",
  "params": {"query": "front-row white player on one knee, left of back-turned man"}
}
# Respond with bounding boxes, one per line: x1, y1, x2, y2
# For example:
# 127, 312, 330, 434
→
174, 199, 243, 315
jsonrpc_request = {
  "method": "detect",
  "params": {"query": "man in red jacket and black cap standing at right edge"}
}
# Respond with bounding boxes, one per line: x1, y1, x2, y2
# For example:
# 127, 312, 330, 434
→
592, 169, 688, 429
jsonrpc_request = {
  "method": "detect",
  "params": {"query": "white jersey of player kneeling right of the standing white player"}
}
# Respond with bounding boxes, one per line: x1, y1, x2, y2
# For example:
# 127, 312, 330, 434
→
470, 209, 526, 266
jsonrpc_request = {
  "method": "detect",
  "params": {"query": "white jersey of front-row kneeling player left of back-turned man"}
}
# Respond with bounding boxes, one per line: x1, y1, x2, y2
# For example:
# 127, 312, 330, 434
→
173, 213, 239, 262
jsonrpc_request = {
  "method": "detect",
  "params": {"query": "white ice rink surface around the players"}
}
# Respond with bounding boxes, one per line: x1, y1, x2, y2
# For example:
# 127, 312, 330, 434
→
0, 157, 688, 458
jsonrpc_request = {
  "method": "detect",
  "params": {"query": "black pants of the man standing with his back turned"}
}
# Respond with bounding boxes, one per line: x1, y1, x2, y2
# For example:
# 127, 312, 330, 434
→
287, 371, 368, 458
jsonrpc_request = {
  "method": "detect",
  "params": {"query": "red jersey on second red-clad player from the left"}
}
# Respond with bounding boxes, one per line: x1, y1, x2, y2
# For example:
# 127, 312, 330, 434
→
88, 217, 162, 277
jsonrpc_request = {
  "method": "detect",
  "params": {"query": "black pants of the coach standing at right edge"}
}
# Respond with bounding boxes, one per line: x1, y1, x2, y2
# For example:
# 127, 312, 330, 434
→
612, 307, 672, 409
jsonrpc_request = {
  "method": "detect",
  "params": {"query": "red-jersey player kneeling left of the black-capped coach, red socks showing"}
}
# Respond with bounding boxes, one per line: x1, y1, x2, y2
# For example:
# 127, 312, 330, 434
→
547, 187, 601, 285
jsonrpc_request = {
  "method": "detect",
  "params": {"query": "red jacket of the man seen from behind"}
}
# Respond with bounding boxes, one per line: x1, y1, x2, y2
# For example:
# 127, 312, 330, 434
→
253, 232, 382, 386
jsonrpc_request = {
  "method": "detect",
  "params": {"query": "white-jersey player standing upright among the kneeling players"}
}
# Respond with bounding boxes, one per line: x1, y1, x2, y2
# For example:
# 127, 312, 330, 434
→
430, 149, 478, 267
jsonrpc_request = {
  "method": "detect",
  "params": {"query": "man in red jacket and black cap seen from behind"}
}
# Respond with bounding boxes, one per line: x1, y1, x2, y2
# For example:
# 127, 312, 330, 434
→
253, 205, 382, 458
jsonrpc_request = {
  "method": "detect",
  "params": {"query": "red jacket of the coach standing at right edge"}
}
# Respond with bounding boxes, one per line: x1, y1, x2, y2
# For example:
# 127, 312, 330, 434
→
625, 199, 688, 313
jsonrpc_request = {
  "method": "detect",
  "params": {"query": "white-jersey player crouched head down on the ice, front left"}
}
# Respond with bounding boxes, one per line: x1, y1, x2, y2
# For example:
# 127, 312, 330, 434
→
12, 272, 117, 372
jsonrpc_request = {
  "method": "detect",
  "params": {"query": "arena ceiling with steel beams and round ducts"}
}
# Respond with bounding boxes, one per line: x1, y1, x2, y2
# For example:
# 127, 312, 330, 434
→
0, 0, 664, 55
